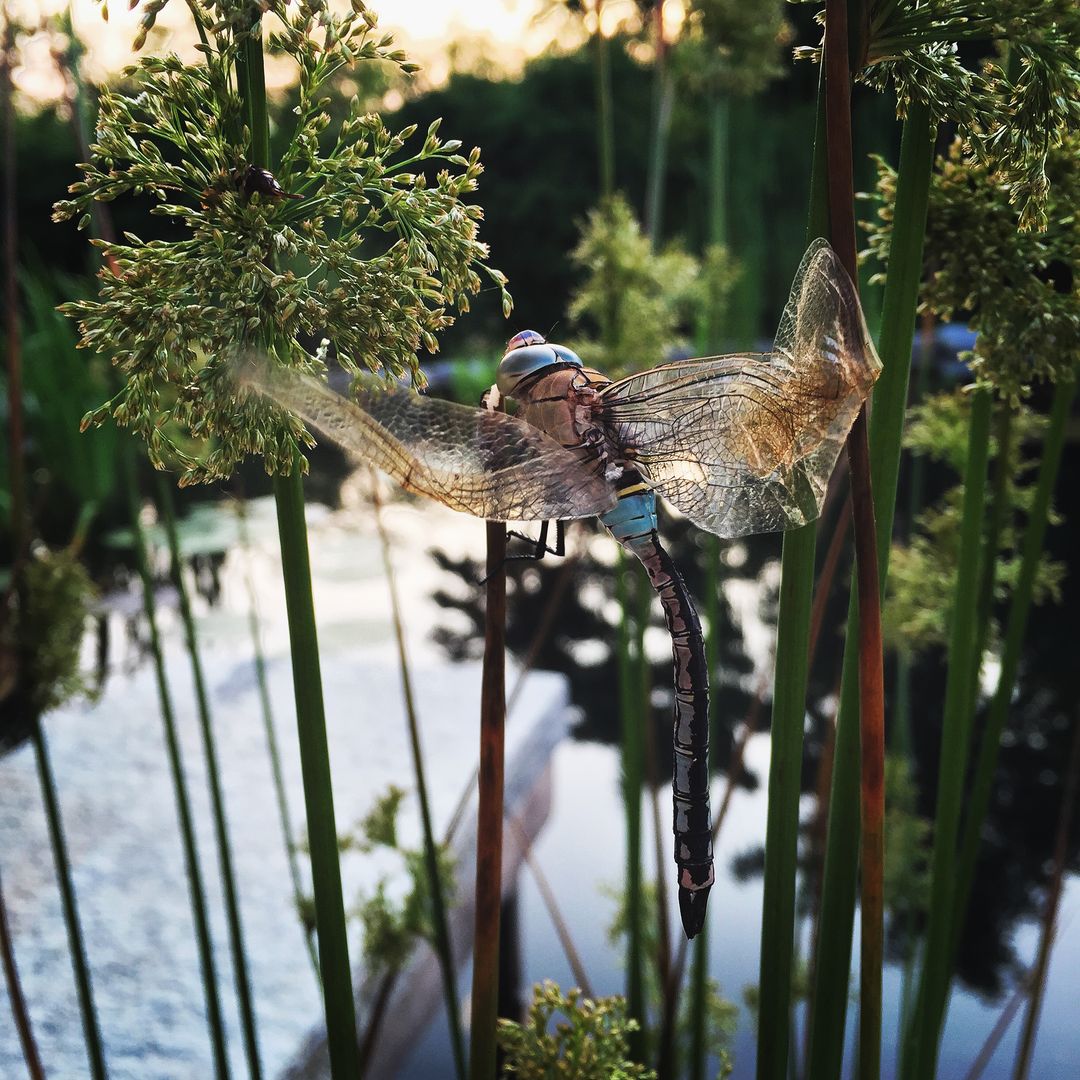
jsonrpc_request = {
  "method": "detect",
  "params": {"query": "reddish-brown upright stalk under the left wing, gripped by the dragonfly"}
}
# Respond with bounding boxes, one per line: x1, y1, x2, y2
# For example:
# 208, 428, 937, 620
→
469, 522, 507, 1080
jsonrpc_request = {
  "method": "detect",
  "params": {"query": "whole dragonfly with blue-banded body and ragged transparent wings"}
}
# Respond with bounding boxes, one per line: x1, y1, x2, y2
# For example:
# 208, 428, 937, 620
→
247, 240, 881, 939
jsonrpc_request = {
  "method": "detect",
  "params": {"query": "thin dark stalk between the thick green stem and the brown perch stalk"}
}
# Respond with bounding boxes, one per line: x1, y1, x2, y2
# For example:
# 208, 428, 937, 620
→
372, 473, 465, 1080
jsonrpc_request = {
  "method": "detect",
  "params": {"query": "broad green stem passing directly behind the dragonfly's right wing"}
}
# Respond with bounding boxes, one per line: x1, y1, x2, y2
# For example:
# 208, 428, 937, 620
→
757, 79, 828, 1080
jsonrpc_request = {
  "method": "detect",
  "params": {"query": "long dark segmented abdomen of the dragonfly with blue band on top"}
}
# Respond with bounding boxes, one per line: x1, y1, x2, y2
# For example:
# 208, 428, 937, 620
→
600, 472, 714, 937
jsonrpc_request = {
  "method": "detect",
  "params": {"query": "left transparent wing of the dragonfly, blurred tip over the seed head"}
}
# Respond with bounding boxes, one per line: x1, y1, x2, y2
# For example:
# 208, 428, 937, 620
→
245, 365, 617, 522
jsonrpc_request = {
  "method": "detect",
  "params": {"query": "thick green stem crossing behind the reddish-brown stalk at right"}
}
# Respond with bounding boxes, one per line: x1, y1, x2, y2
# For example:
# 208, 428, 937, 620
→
807, 90, 934, 1080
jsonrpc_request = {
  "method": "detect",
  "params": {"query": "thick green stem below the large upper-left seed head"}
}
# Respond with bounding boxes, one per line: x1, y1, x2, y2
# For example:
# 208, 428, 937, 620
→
273, 468, 360, 1080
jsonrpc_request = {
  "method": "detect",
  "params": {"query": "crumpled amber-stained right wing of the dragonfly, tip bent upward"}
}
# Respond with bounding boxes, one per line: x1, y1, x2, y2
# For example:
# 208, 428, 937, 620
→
602, 240, 881, 538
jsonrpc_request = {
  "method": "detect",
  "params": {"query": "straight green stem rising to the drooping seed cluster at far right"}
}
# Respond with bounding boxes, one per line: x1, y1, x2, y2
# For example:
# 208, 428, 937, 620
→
904, 387, 994, 1077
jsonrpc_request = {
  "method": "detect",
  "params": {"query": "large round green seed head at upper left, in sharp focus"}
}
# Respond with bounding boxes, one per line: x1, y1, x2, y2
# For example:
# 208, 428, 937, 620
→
55, 0, 510, 483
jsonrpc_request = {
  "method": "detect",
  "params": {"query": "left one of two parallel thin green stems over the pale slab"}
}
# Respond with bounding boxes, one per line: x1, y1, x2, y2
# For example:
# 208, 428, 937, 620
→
122, 445, 229, 1080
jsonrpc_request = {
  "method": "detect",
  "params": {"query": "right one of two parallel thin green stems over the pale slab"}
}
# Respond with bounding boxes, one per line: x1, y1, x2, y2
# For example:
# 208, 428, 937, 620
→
157, 473, 262, 1080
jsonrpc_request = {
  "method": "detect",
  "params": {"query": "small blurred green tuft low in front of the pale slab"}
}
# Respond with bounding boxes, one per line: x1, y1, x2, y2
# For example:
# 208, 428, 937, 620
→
338, 784, 455, 972
